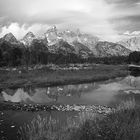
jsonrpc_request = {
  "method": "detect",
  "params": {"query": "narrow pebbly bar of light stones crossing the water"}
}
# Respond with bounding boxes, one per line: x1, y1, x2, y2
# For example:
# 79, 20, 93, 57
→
0, 102, 113, 114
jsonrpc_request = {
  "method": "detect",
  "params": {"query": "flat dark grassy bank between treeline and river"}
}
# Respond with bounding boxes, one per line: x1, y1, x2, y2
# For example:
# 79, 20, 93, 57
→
0, 65, 128, 88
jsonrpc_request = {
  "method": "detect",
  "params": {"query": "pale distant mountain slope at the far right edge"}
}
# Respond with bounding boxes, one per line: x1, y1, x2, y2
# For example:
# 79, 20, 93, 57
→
118, 36, 140, 51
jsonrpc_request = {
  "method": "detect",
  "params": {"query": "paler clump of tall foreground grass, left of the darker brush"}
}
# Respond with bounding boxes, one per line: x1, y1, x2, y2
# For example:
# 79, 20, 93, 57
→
19, 115, 79, 140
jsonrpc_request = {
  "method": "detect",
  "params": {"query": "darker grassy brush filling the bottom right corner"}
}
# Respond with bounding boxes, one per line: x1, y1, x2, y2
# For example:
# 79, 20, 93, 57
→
73, 99, 140, 140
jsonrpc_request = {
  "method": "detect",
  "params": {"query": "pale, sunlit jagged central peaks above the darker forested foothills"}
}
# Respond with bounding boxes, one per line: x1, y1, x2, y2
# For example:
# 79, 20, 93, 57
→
45, 26, 99, 53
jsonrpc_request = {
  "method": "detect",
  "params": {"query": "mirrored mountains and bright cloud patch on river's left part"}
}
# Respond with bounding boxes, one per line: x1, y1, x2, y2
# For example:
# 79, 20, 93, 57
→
1, 83, 95, 103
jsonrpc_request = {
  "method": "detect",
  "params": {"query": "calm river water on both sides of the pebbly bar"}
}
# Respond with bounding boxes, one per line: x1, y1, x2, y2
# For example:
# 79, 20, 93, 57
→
0, 76, 140, 140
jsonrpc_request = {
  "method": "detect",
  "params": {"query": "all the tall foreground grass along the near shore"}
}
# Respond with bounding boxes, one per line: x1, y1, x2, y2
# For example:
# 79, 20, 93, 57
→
19, 100, 140, 140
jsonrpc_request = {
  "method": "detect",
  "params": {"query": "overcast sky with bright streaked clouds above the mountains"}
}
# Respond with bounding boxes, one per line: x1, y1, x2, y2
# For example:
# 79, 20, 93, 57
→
0, 0, 140, 41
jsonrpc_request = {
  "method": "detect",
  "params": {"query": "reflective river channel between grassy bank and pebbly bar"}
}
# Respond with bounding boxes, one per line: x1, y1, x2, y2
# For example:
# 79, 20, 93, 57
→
1, 76, 140, 105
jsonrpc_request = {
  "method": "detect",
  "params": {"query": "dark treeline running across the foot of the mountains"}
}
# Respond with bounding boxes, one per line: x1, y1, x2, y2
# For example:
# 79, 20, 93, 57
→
0, 41, 130, 67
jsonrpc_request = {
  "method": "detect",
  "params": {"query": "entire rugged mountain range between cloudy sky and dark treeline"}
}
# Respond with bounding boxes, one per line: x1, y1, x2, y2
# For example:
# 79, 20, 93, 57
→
0, 26, 132, 58
